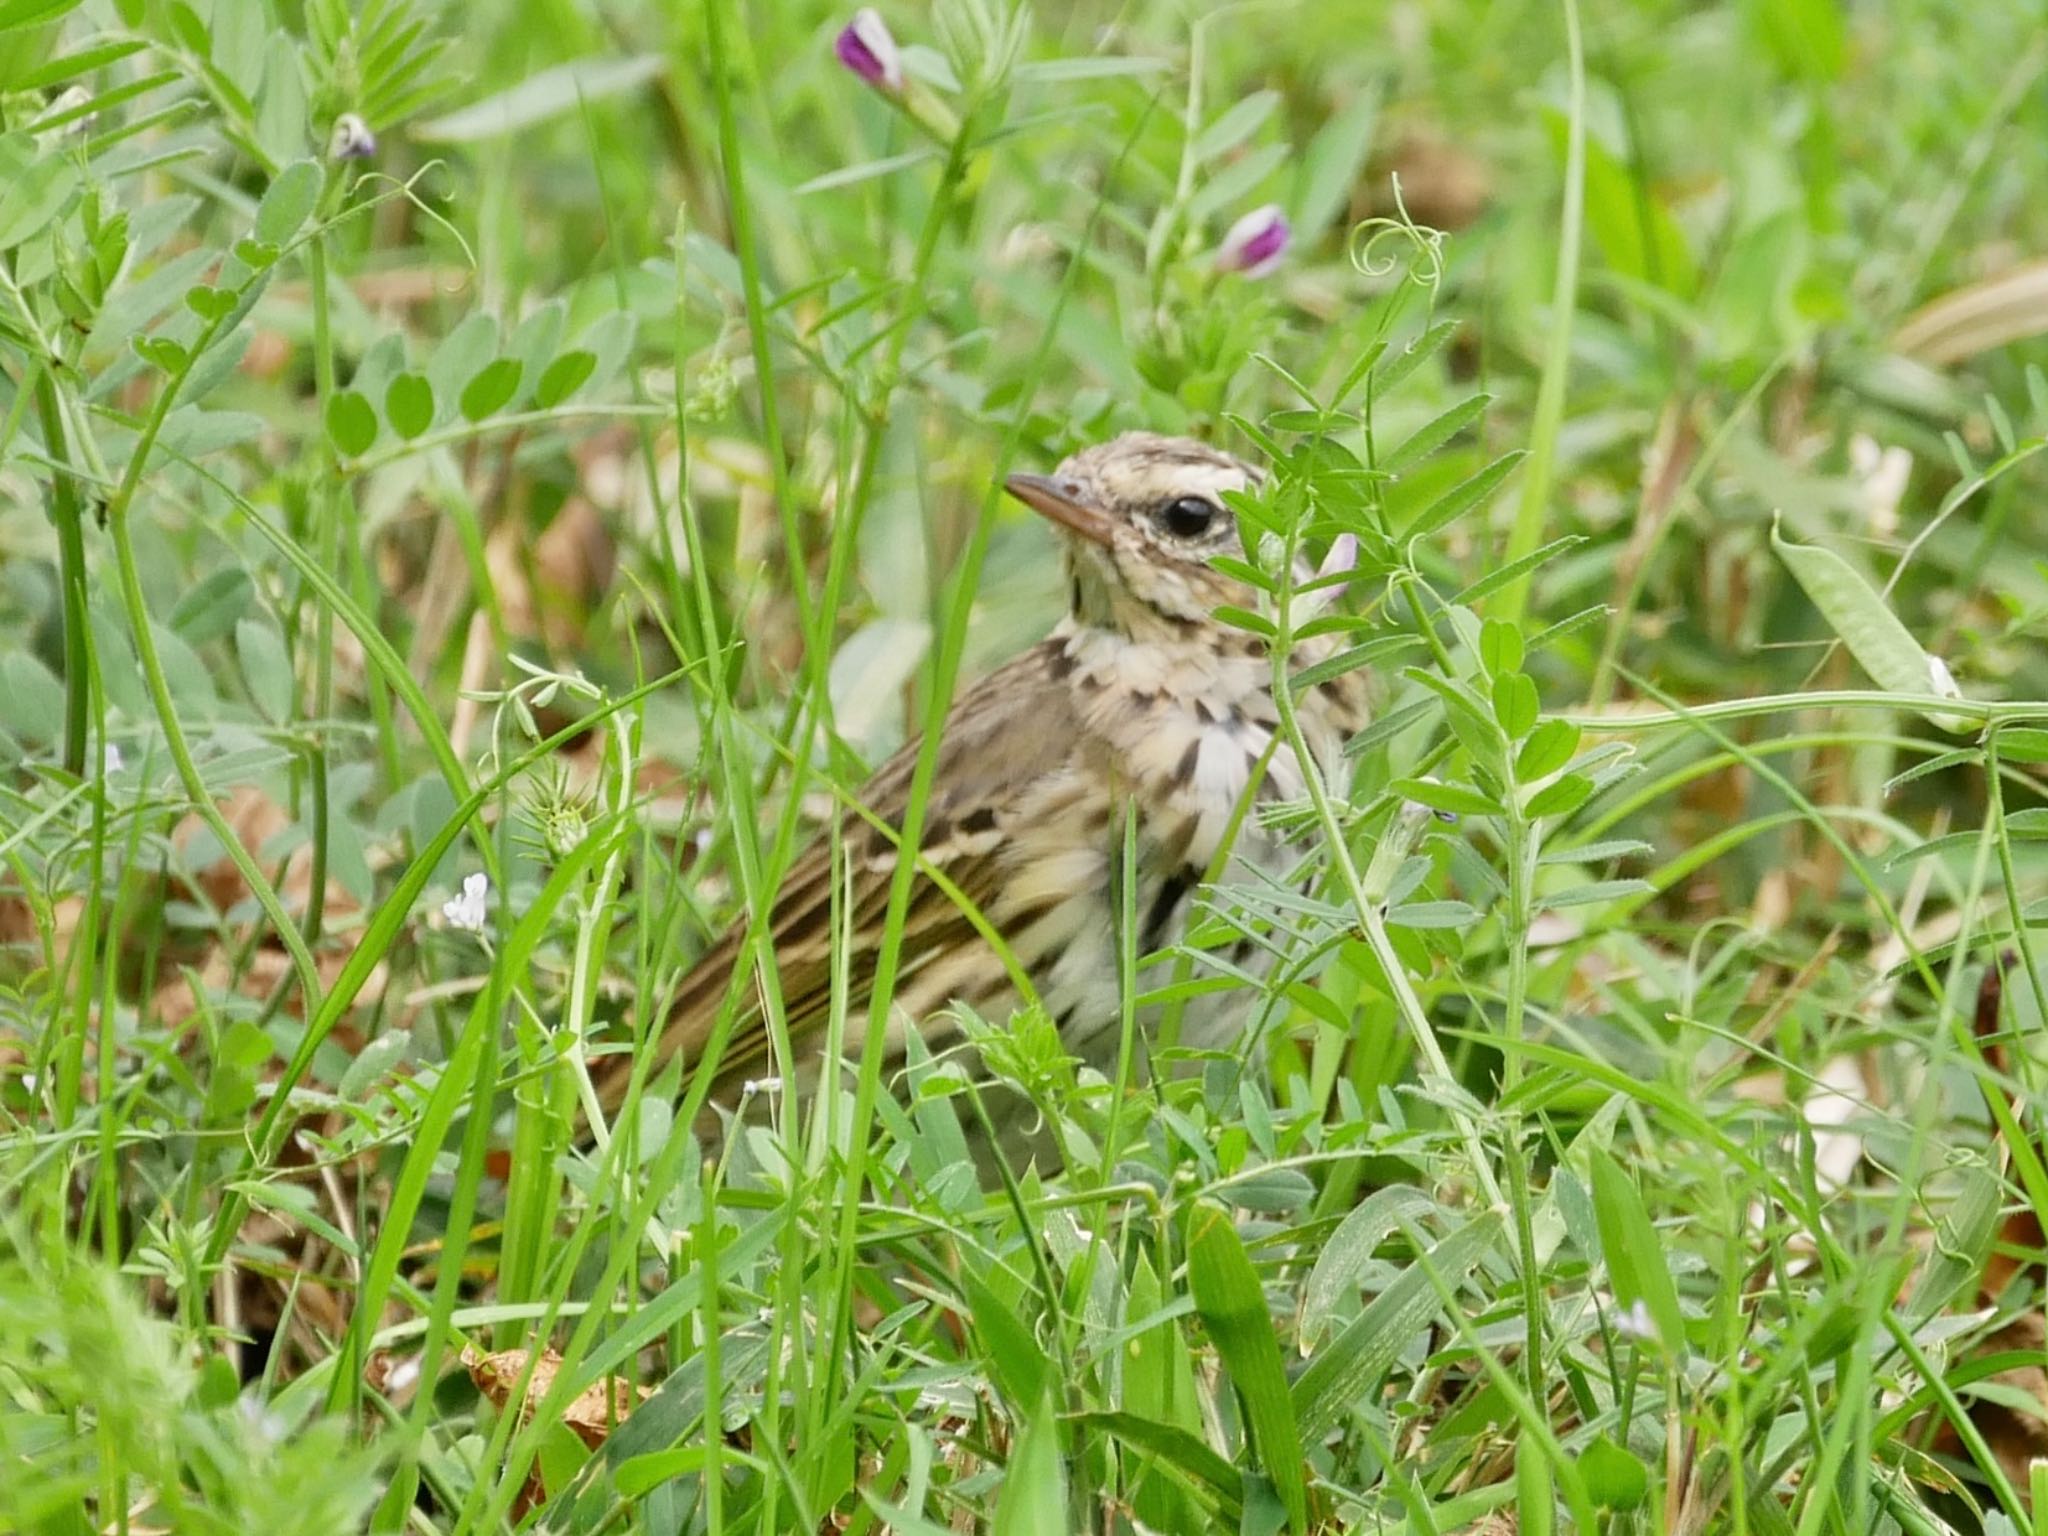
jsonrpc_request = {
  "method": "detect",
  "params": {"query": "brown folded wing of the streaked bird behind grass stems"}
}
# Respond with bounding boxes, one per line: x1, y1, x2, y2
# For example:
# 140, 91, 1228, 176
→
598, 641, 1079, 1106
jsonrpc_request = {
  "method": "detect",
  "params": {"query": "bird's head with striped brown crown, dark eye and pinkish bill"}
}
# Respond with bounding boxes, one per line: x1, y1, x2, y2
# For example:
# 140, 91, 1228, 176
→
1006, 432, 1264, 637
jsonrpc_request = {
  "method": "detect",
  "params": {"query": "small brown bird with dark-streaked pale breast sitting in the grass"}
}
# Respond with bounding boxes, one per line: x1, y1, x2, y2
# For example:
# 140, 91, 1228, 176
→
600, 432, 1366, 1130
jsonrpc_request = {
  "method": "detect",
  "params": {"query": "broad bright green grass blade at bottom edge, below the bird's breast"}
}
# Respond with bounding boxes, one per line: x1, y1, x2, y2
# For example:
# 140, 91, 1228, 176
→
1188, 1204, 1309, 1532
